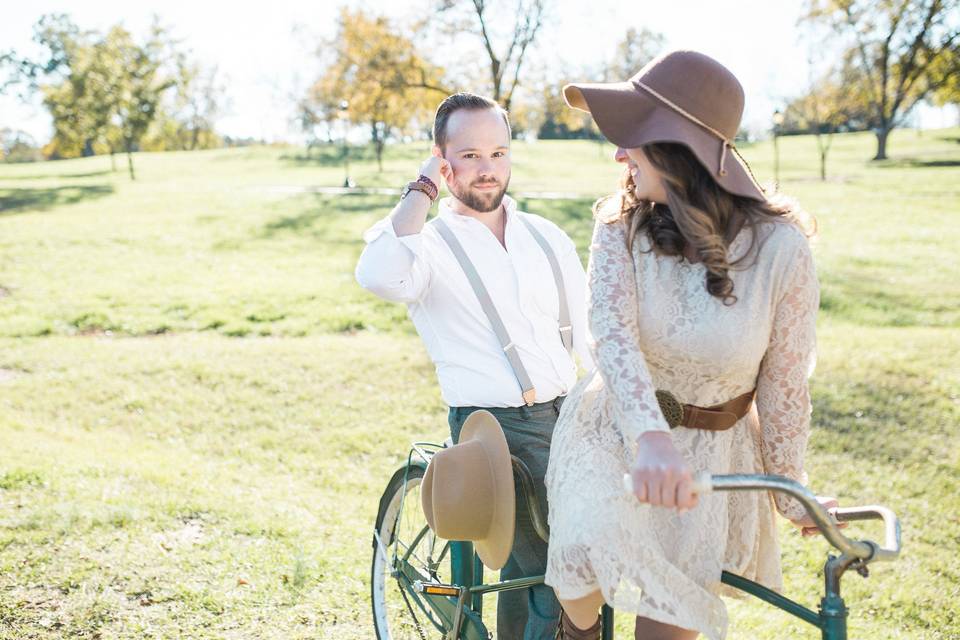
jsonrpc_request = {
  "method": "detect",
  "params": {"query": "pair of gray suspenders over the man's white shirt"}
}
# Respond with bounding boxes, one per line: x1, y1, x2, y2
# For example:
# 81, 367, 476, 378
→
435, 215, 573, 406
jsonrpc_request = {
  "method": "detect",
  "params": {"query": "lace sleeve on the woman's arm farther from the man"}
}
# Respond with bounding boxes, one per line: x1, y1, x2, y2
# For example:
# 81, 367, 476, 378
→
757, 239, 820, 520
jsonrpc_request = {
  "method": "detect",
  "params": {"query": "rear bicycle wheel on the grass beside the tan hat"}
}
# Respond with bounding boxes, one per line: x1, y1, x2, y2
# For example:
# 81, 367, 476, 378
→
370, 466, 450, 640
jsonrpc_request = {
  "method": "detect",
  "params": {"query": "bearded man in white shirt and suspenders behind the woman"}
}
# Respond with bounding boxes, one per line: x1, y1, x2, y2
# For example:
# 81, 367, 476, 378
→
356, 93, 593, 640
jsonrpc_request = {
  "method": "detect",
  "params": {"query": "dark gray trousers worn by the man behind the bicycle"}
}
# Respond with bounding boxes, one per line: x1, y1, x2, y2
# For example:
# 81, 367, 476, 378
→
447, 397, 563, 640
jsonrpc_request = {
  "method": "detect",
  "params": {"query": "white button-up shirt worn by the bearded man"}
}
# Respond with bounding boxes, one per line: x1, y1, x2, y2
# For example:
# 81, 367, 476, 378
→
356, 192, 593, 407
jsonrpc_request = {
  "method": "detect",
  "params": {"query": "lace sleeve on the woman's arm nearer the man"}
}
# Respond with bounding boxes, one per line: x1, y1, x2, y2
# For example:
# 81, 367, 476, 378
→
587, 216, 670, 448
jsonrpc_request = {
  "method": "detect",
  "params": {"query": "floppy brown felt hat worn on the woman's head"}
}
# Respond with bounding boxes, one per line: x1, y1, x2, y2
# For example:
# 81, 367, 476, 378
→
563, 51, 766, 200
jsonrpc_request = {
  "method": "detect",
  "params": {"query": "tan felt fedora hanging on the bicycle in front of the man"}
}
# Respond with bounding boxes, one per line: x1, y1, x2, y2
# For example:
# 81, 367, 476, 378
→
420, 411, 516, 569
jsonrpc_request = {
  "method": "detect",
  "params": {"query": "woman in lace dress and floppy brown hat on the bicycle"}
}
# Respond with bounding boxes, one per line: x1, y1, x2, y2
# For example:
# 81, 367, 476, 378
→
546, 51, 836, 639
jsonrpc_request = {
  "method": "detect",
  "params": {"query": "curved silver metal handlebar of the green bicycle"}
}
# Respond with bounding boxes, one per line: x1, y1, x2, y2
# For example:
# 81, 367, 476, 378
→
623, 473, 900, 563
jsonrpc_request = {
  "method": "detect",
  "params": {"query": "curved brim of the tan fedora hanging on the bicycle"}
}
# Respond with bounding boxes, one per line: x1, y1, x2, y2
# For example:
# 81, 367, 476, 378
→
458, 410, 517, 570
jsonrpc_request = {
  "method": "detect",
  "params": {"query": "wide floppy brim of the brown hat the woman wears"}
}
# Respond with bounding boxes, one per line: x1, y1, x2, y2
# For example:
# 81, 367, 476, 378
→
563, 82, 767, 202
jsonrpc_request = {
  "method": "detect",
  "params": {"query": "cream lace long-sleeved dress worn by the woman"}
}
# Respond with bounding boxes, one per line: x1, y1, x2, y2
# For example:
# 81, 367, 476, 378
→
546, 211, 819, 640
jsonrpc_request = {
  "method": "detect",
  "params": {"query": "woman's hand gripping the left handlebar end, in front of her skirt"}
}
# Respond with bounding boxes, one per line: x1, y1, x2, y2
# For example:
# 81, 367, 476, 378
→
630, 431, 697, 511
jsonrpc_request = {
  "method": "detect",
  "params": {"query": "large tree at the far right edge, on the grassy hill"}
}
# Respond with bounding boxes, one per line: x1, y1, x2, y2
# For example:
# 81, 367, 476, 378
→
804, 0, 960, 160
